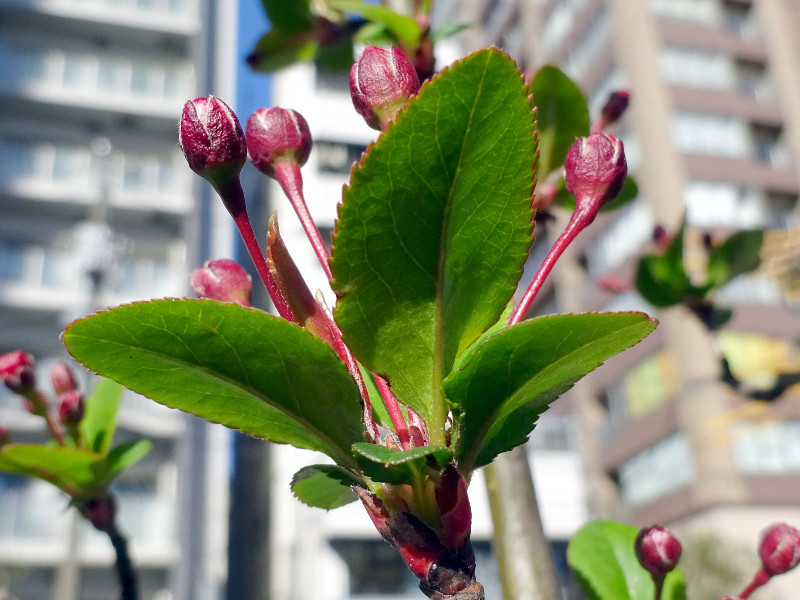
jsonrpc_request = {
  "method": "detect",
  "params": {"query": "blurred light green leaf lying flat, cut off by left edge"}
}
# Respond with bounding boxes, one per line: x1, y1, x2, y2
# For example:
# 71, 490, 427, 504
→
0, 444, 102, 496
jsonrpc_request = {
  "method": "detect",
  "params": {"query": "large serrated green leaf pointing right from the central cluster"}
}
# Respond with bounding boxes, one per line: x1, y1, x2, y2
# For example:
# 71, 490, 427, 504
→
444, 313, 656, 473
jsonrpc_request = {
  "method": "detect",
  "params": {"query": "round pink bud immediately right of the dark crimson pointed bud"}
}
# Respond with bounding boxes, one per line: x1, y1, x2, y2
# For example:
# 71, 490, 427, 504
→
247, 107, 312, 177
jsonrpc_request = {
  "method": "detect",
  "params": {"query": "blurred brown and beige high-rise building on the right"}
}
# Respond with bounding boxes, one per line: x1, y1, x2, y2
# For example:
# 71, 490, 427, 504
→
437, 0, 800, 598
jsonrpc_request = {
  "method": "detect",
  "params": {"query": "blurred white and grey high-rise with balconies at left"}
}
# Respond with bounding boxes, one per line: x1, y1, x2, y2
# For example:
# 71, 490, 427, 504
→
0, 0, 236, 600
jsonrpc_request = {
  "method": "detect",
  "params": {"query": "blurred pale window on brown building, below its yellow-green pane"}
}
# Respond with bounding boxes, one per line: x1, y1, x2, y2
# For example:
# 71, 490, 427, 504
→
619, 433, 694, 506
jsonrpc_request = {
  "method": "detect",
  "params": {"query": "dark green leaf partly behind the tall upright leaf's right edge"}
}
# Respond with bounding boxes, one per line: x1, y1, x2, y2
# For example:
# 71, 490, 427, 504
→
530, 65, 589, 179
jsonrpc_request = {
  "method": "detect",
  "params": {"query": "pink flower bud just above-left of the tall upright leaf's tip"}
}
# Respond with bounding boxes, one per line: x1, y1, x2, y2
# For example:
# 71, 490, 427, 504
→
350, 46, 419, 130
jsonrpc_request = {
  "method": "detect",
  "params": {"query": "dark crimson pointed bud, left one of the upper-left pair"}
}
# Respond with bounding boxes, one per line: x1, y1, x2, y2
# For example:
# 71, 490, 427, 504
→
178, 96, 247, 188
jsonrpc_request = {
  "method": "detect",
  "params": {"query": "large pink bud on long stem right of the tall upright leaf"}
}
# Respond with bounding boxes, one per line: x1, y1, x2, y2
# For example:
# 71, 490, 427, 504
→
564, 133, 628, 214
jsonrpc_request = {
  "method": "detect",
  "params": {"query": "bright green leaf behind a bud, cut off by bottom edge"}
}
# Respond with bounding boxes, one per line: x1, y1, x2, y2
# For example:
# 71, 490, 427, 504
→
567, 521, 686, 600
